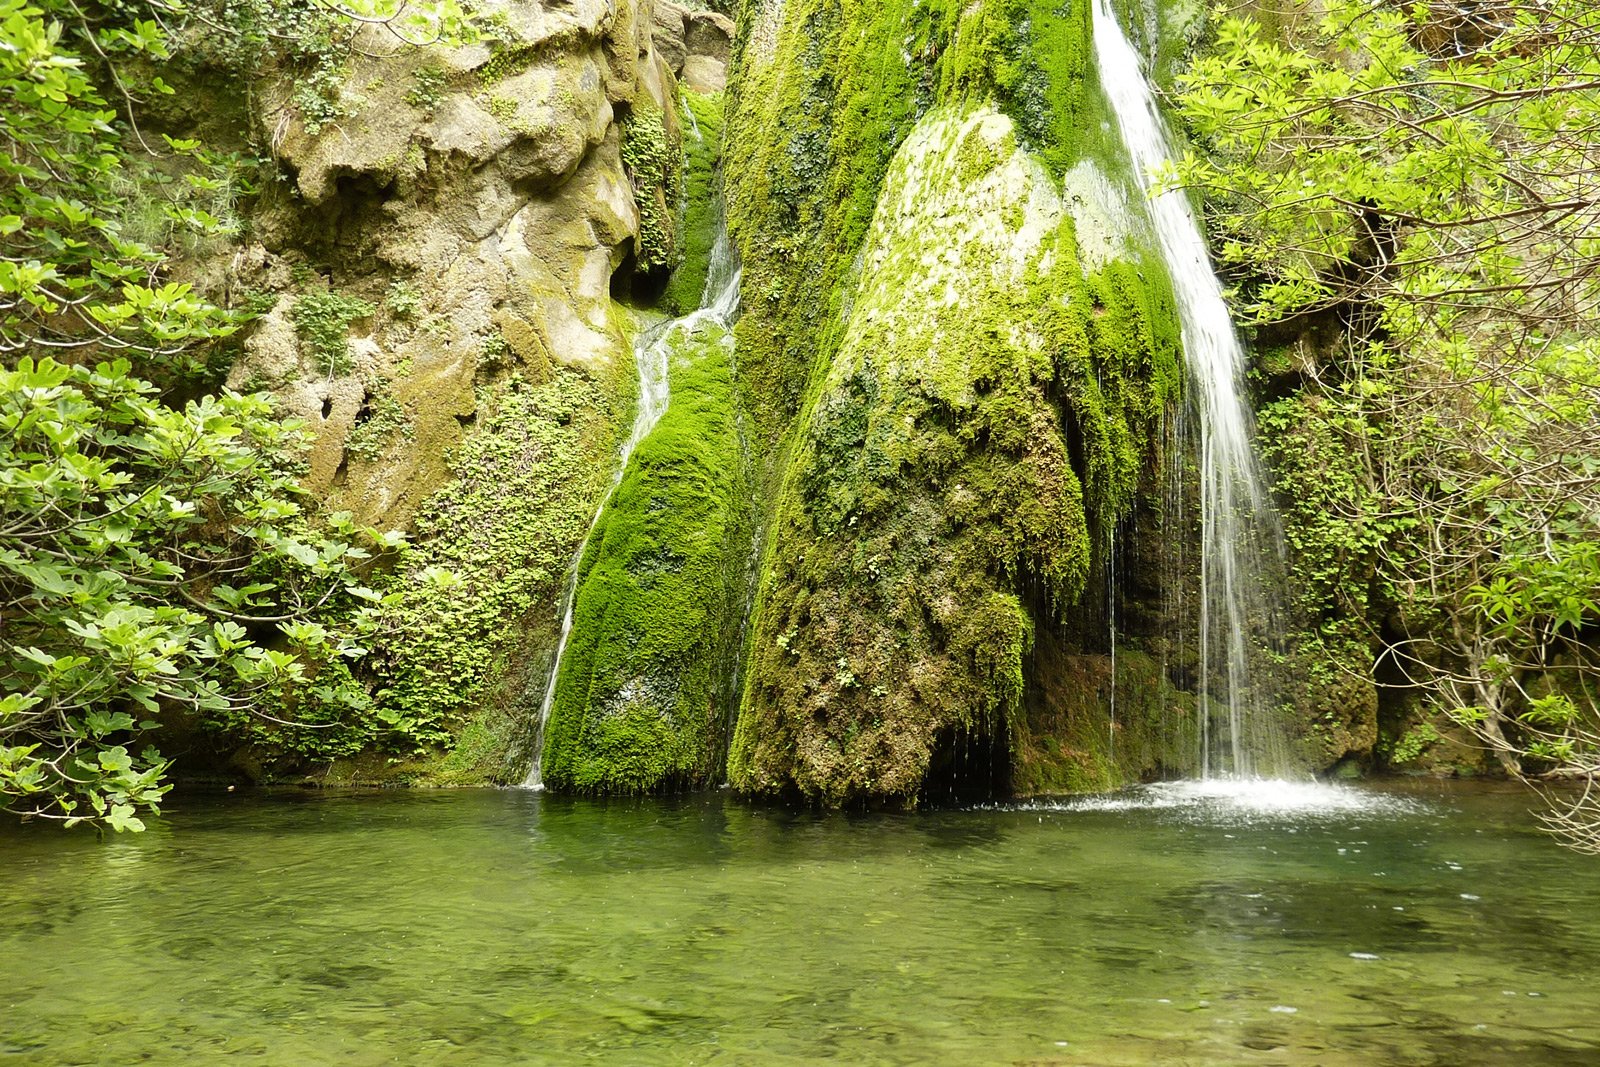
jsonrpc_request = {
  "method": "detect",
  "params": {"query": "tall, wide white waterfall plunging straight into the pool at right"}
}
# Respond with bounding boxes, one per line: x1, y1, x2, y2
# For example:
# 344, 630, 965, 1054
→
1094, 0, 1285, 777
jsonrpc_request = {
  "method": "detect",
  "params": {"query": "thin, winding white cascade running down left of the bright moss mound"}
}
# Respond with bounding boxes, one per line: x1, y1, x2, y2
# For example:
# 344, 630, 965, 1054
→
523, 227, 741, 790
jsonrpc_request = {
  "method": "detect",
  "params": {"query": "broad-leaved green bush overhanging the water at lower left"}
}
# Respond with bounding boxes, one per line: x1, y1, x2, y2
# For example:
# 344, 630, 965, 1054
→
0, 357, 394, 829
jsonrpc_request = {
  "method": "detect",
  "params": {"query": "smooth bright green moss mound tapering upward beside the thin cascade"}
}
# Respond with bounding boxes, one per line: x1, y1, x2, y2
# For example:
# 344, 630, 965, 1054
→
542, 316, 750, 793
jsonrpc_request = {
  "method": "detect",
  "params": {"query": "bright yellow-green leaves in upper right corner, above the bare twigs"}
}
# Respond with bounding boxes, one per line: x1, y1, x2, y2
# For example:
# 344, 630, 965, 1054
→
1179, 0, 1600, 336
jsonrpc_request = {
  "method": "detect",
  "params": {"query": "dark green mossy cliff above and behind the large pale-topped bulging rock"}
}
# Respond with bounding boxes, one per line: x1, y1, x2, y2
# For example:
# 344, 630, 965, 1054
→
725, 0, 1099, 456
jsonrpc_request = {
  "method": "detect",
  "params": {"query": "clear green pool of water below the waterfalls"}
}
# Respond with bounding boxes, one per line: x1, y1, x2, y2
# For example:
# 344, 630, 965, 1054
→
0, 787, 1600, 1067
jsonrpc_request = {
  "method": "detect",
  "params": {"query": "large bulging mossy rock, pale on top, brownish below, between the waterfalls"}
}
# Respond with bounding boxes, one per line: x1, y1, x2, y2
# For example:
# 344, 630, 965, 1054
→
730, 95, 1176, 805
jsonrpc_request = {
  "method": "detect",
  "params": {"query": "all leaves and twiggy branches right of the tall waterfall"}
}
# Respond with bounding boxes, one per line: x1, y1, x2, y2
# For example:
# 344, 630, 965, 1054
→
1176, 0, 1600, 845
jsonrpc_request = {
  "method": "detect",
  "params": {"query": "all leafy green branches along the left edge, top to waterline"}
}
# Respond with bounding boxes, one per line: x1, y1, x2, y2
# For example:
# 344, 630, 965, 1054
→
0, 0, 486, 829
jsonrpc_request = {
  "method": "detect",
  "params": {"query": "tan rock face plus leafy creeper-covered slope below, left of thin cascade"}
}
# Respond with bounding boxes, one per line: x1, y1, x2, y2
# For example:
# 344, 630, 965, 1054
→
193, 0, 707, 782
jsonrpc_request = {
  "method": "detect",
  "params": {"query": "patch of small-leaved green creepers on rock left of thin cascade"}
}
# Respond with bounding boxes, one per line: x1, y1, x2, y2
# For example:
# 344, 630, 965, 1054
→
366, 368, 627, 781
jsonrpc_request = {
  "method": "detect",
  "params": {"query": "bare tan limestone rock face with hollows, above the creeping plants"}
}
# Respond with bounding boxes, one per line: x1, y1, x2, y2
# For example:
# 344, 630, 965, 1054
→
232, 0, 672, 528
